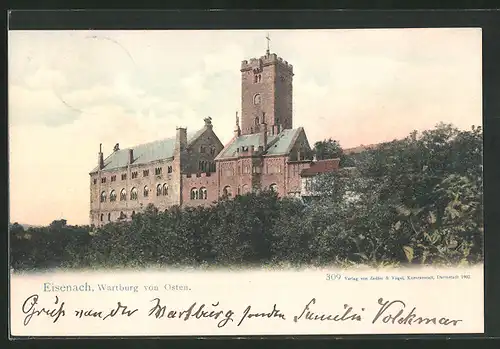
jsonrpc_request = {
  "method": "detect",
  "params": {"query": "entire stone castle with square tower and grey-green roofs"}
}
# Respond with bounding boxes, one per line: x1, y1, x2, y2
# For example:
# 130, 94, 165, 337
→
90, 49, 335, 226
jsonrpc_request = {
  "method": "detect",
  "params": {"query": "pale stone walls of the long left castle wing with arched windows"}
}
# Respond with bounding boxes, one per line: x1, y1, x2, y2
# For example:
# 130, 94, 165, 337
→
90, 120, 223, 226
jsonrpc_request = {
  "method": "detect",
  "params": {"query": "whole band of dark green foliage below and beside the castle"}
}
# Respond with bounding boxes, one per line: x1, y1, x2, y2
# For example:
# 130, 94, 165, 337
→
10, 124, 483, 269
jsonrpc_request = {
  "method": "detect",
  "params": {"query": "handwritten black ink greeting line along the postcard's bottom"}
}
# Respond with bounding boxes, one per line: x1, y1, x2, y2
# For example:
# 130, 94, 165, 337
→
21, 294, 463, 328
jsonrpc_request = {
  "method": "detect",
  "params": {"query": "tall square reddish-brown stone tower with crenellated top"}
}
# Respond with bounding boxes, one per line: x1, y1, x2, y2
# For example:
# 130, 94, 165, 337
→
240, 50, 293, 135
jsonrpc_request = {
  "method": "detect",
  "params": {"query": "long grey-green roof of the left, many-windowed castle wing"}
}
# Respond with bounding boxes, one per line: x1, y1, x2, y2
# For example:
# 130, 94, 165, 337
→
90, 127, 207, 173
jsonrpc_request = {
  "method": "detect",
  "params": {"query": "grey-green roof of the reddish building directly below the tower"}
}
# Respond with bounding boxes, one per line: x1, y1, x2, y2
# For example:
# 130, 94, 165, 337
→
215, 127, 303, 160
